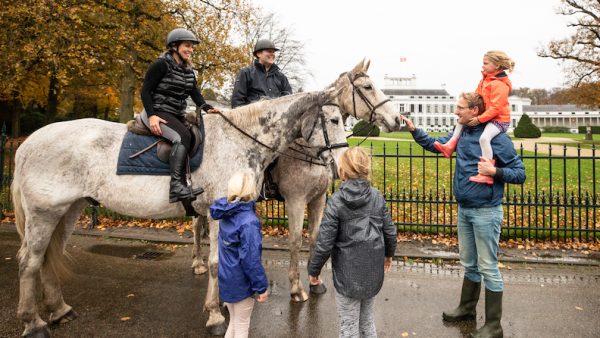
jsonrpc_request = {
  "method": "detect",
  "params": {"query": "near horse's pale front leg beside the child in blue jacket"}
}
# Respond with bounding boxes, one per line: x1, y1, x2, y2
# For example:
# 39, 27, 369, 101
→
204, 218, 227, 336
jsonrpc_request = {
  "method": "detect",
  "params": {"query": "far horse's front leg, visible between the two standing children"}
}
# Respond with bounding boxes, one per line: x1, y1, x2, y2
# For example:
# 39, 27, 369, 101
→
286, 199, 308, 302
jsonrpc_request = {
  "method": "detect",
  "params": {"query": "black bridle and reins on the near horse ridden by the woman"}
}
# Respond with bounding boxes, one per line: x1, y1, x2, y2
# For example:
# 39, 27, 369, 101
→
217, 103, 349, 167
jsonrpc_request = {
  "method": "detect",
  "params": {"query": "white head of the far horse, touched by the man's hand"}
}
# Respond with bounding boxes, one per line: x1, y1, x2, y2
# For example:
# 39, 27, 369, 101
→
334, 59, 400, 132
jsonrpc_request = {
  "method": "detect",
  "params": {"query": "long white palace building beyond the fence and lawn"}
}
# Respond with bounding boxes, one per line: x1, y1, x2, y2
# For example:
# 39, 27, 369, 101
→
348, 75, 600, 132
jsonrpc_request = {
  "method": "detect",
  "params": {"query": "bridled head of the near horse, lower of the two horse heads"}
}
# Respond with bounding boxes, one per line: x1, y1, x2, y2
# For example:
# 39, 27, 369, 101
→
301, 88, 348, 172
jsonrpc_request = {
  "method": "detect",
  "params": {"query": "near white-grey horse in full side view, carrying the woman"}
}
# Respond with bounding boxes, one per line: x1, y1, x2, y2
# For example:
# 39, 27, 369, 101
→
11, 90, 346, 337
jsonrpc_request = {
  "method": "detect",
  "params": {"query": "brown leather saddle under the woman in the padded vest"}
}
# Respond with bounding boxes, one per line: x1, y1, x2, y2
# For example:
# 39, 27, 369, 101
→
127, 112, 204, 163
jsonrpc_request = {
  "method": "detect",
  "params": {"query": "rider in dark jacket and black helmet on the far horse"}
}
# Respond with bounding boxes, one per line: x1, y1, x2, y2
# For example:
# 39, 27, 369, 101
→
231, 39, 292, 198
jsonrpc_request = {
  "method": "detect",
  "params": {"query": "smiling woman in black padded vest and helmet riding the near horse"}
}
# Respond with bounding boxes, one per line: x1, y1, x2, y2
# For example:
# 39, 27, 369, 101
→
141, 28, 219, 203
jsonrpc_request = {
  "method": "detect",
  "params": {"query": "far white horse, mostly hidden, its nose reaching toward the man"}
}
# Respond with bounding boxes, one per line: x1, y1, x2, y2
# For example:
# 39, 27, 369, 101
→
192, 60, 400, 302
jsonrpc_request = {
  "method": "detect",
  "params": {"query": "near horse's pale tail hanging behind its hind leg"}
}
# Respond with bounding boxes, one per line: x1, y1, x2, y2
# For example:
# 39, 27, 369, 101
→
10, 175, 72, 280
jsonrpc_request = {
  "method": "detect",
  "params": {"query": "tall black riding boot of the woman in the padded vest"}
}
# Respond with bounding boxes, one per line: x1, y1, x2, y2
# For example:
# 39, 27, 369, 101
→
169, 142, 204, 203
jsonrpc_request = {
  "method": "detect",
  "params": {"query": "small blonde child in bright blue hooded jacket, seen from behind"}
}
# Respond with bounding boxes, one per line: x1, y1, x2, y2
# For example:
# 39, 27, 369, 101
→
210, 171, 269, 338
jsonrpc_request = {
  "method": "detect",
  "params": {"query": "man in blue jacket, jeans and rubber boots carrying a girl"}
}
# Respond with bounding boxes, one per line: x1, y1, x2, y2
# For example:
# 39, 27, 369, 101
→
403, 93, 525, 337
